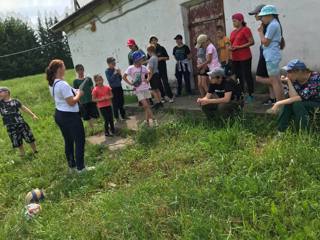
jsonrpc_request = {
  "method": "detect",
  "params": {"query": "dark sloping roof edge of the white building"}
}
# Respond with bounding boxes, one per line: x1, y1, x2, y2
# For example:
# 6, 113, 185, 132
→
51, 0, 104, 31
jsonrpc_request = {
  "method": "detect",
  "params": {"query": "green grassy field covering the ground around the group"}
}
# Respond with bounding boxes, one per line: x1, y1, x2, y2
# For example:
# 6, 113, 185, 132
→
0, 72, 320, 240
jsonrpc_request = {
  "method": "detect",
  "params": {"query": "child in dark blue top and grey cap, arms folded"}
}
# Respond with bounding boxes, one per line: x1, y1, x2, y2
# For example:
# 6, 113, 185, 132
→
105, 57, 127, 121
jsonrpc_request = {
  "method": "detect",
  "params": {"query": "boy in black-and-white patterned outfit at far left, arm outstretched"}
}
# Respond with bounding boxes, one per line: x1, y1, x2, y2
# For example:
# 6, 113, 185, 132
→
0, 87, 38, 157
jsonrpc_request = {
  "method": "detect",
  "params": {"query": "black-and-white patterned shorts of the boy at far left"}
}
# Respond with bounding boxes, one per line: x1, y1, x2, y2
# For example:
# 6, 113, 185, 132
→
7, 123, 36, 148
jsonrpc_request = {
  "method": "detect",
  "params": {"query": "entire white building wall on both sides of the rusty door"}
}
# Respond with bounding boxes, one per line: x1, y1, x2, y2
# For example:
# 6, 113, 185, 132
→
67, 0, 320, 87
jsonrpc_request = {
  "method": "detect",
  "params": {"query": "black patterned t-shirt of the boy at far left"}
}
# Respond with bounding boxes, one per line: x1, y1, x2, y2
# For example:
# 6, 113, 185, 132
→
0, 99, 24, 126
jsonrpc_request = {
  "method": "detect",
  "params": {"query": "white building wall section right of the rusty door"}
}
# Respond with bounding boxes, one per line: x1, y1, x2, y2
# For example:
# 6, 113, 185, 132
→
224, 0, 320, 70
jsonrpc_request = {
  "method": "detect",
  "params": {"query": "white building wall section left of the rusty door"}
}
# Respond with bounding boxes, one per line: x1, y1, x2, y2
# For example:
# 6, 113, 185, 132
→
67, 0, 190, 85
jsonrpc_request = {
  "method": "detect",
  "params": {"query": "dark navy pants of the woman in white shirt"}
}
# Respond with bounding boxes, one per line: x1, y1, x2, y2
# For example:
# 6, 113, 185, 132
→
54, 110, 86, 170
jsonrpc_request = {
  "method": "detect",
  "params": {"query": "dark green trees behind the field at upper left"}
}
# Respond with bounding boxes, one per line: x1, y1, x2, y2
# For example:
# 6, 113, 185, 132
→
0, 18, 73, 80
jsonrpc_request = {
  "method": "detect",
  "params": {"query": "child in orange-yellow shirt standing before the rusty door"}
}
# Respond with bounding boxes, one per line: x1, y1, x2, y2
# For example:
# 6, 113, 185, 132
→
217, 26, 231, 75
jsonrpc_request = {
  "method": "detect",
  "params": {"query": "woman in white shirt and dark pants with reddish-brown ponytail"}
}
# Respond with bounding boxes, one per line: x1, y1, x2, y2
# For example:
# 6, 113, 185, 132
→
46, 59, 92, 172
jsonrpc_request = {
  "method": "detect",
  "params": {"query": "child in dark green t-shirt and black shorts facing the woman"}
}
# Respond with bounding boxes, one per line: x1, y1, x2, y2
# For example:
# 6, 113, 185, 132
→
73, 64, 99, 129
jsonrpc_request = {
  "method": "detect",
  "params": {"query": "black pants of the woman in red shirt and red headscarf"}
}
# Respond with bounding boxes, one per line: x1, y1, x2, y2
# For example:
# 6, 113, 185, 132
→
232, 59, 254, 96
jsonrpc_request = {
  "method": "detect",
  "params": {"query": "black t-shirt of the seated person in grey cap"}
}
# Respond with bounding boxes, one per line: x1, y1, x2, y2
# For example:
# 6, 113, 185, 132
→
208, 80, 241, 100
